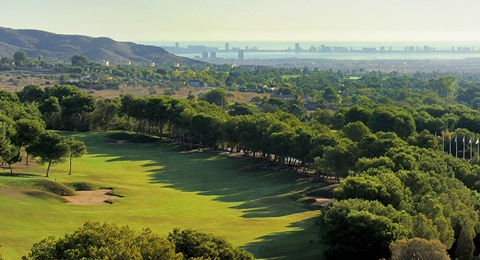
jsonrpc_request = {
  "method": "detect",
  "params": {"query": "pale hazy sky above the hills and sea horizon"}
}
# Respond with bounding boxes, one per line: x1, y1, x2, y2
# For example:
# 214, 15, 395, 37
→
0, 0, 480, 42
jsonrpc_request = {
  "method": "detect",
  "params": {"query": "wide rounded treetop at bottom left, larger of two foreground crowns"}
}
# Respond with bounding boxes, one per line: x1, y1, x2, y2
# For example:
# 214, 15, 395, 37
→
23, 222, 182, 260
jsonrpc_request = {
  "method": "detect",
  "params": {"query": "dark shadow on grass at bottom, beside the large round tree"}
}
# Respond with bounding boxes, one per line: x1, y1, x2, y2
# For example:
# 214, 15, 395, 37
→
242, 218, 324, 259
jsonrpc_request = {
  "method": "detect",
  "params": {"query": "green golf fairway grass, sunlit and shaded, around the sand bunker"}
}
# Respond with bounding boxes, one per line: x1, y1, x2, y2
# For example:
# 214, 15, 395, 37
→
0, 133, 322, 259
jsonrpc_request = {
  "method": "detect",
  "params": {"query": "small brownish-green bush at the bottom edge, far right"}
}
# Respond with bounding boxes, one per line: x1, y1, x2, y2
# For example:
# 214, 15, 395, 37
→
390, 237, 450, 260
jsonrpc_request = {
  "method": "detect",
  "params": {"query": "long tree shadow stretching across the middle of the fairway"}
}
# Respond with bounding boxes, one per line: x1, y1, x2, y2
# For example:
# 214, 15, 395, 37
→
86, 132, 322, 218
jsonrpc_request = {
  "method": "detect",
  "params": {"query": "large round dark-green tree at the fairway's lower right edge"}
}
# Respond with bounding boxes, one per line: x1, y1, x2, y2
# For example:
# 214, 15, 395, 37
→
318, 199, 412, 259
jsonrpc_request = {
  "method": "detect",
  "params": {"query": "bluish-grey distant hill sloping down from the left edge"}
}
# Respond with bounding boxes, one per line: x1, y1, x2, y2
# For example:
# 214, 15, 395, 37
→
0, 27, 201, 65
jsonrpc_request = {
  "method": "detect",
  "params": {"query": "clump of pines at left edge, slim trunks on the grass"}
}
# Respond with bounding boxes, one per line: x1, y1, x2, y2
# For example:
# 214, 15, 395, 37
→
0, 90, 86, 177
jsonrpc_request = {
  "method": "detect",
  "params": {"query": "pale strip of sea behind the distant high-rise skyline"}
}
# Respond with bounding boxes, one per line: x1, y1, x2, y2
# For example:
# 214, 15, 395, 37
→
138, 41, 480, 60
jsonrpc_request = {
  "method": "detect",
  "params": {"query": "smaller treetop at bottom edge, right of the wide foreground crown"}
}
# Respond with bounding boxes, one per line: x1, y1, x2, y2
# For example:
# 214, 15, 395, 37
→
168, 228, 254, 260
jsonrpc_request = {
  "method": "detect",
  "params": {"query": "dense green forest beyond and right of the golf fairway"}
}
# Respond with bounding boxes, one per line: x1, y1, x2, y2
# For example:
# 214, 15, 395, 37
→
0, 54, 480, 259
